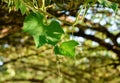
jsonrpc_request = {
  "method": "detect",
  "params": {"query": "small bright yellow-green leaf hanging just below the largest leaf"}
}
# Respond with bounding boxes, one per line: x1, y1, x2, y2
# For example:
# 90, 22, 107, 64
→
54, 40, 78, 57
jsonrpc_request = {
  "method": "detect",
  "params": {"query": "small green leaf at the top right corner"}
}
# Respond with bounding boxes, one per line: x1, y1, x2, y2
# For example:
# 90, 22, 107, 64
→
98, 0, 118, 11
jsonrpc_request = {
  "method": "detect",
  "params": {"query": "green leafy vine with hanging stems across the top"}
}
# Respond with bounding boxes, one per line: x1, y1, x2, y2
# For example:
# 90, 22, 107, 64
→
2, 0, 118, 56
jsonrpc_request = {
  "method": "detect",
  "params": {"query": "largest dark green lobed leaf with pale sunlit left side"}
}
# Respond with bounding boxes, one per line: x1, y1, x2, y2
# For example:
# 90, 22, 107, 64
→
23, 13, 64, 47
